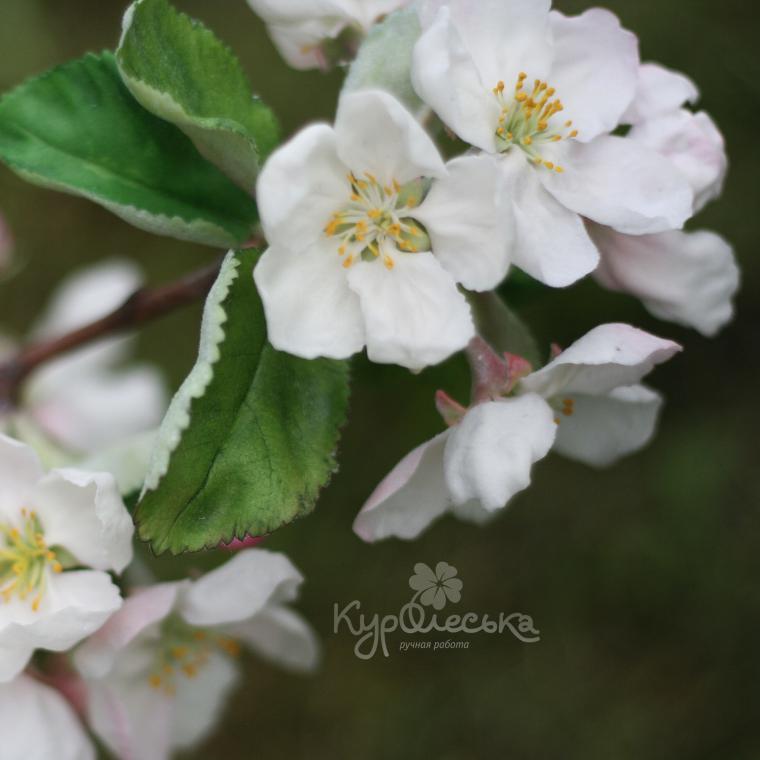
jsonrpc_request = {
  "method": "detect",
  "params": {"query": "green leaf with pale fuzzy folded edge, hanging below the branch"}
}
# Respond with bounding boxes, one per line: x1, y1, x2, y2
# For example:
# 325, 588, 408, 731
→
136, 250, 348, 554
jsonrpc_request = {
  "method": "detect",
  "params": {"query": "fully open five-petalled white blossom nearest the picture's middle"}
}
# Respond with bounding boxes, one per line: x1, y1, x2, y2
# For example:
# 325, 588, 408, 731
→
255, 91, 507, 370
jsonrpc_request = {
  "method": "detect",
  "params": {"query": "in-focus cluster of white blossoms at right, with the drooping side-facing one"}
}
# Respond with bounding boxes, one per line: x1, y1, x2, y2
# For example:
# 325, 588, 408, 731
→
251, 0, 739, 541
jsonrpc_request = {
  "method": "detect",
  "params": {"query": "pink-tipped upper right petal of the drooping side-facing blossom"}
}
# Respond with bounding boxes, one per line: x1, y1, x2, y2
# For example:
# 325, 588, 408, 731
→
520, 324, 681, 398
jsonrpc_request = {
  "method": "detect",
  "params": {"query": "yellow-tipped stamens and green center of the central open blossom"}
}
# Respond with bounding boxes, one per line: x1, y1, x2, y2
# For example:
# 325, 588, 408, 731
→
324, 172, 429, 269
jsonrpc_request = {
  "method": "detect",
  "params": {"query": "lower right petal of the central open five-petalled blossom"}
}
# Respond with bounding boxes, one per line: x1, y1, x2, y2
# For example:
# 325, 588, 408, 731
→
348, 253, 475, 370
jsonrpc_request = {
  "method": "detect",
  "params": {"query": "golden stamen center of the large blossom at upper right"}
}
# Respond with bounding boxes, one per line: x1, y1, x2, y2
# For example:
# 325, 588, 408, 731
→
493, 72, 578, 174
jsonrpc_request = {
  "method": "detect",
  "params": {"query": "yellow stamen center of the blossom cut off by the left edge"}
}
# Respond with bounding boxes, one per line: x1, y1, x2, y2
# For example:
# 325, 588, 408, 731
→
0, 509, 63, 612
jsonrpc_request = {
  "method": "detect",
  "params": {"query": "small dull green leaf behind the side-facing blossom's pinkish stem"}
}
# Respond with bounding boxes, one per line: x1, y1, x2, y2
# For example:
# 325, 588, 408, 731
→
467, 292, 543, 368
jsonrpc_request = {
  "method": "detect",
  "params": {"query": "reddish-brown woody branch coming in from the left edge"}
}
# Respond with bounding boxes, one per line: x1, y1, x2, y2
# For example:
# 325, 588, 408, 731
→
0, 262, 220, 411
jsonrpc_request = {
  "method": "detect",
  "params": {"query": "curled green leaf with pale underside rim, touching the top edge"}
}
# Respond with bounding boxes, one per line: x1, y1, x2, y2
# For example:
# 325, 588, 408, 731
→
116, 0, 278, 191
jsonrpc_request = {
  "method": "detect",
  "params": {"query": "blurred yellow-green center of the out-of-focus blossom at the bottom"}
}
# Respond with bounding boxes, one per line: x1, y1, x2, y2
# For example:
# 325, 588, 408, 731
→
148, 617, 240, 696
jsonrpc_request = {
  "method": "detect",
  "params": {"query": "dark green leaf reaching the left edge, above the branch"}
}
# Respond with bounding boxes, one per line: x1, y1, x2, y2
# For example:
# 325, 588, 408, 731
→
0, 53, 257, 248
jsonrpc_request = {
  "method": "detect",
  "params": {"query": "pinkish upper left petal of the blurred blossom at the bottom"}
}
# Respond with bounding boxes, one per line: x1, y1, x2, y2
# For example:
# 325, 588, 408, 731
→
74, 581, 184, 679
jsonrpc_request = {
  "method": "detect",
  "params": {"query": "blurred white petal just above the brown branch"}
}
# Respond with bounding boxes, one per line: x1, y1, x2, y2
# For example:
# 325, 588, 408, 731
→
32, 259, 143, 340
